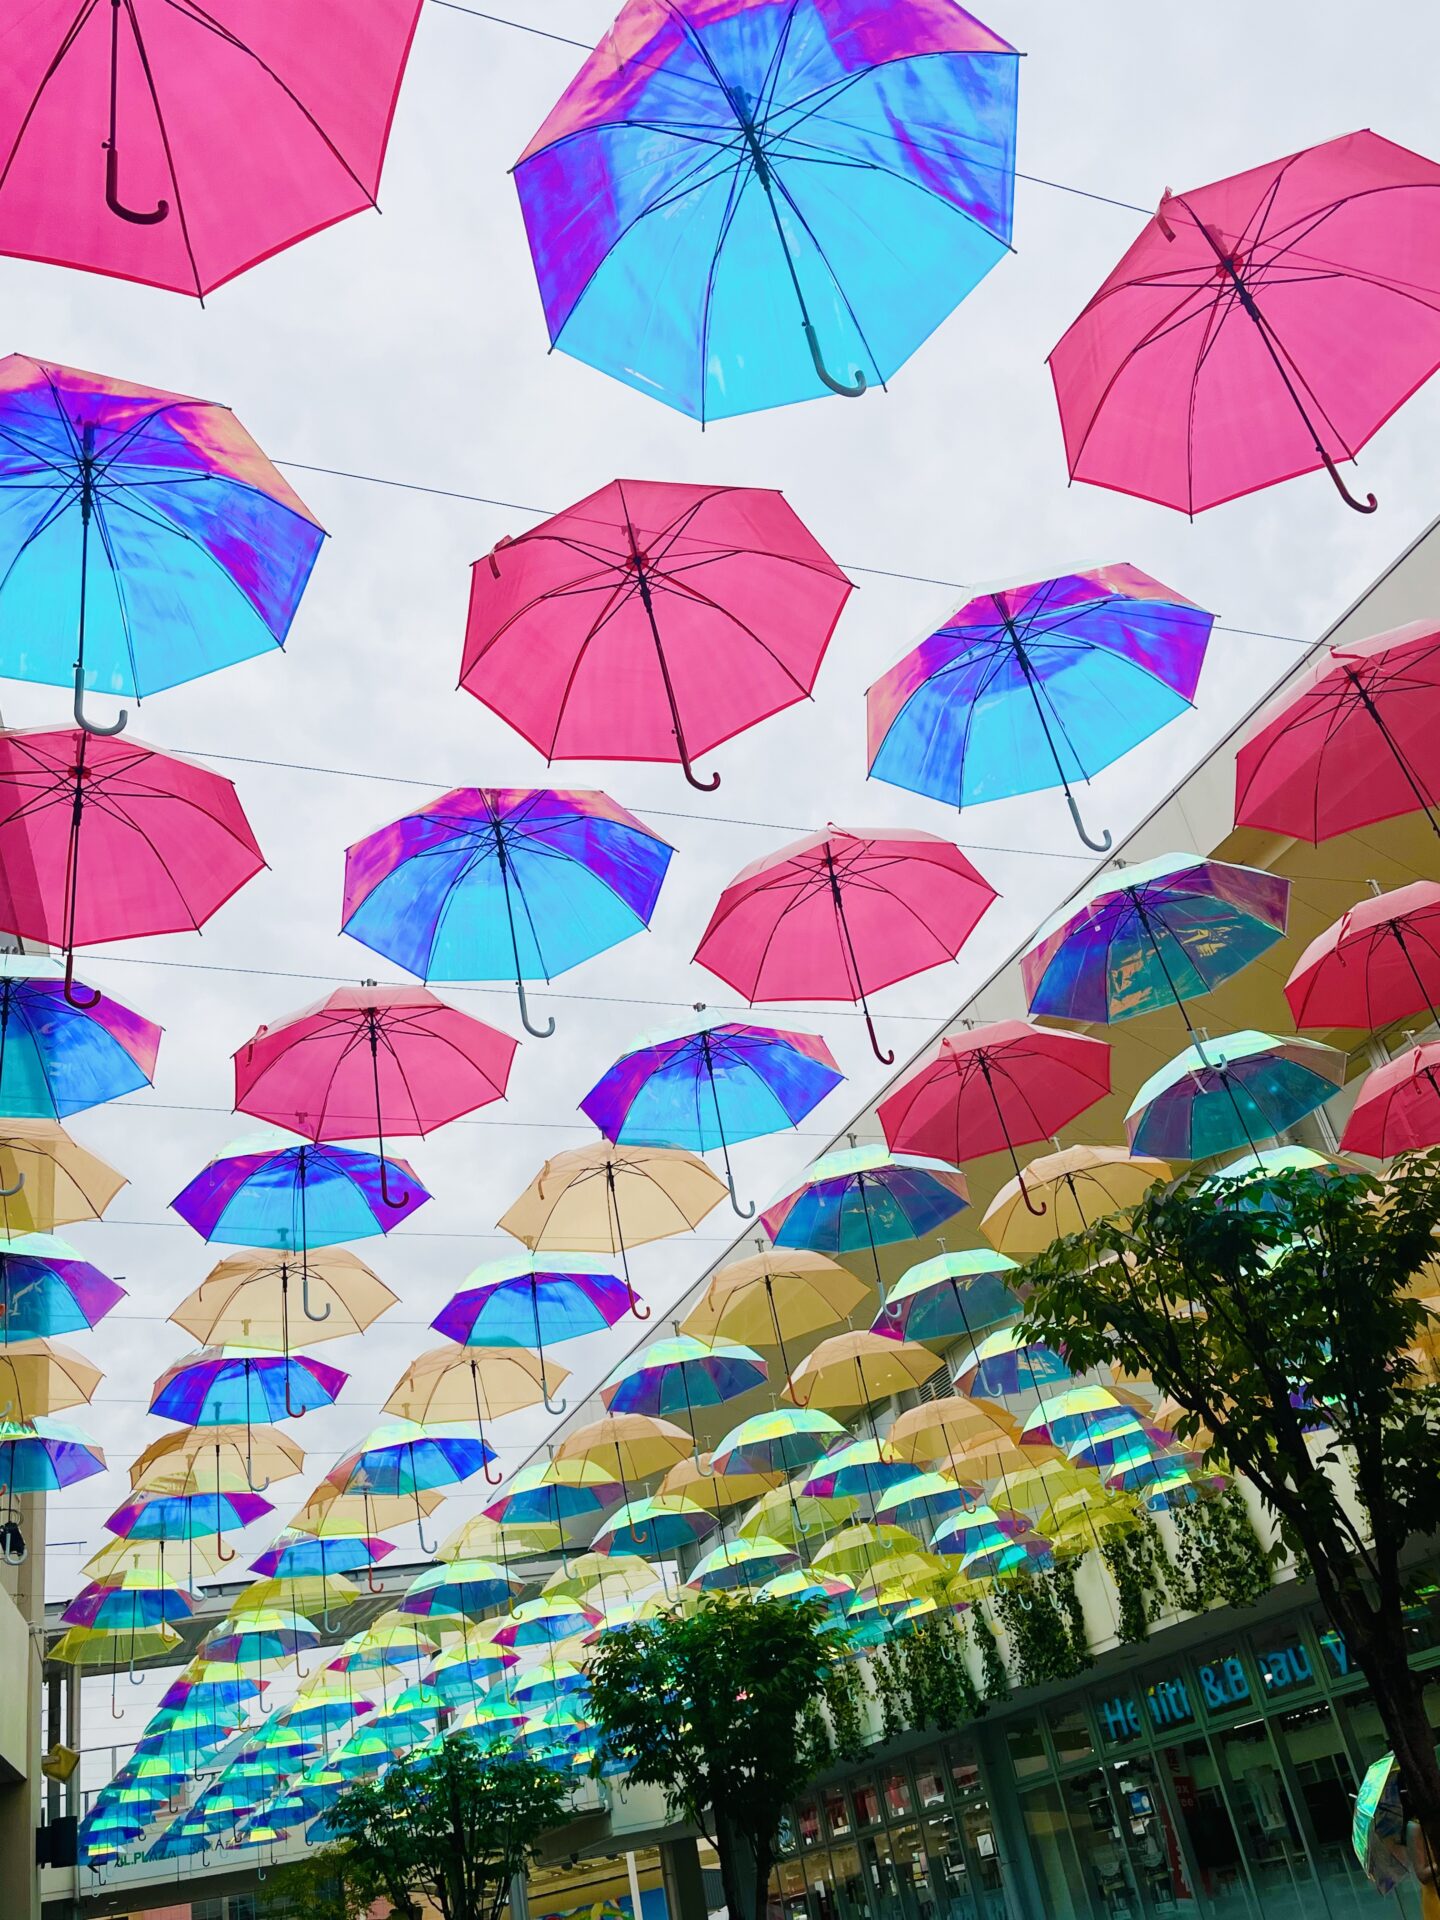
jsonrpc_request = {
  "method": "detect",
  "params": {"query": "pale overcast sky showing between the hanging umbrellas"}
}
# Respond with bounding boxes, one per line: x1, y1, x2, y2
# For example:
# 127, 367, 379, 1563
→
0, 0, 1440, 1766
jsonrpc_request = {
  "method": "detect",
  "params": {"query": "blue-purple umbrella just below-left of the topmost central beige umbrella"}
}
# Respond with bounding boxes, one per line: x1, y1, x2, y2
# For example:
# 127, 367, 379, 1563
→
430, 1254, 630, 1415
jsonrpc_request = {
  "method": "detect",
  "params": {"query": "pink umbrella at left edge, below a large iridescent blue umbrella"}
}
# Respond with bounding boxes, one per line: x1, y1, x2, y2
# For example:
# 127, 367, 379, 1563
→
0, 728, 265, 1006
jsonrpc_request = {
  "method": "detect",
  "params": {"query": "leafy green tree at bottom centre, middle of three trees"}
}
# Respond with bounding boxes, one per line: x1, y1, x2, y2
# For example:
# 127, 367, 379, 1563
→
589, 1594, 845, 1920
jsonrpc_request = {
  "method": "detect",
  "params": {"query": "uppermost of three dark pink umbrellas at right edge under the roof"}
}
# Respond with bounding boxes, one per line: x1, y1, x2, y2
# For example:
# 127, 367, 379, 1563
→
1235, 620, 1440, 845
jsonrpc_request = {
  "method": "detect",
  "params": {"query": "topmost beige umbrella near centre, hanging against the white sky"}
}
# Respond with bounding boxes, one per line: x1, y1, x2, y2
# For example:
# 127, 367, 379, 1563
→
499, 1144, 726, 1319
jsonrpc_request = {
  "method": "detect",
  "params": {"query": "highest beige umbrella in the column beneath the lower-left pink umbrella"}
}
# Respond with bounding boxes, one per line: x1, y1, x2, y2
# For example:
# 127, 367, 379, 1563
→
171, 1246, 396, 1354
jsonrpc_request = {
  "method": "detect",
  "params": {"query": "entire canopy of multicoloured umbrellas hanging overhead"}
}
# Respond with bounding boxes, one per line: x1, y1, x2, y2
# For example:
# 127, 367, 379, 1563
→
0, 0, 1440, 1862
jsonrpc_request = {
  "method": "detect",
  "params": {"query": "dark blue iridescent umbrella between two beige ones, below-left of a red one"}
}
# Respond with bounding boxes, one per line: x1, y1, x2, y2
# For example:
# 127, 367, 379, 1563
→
760, 1144, 970, 1284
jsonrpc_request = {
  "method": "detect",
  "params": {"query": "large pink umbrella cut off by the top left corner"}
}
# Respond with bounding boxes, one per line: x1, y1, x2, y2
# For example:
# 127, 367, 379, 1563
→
0, 0, 420, 296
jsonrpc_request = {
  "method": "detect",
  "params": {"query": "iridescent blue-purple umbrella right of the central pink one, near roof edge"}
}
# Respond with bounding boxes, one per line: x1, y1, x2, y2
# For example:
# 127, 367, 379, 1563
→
866, 566, 1213, 852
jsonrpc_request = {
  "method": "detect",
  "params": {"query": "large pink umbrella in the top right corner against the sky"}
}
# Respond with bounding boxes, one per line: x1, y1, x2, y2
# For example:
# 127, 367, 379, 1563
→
1050, 132, 1440, 515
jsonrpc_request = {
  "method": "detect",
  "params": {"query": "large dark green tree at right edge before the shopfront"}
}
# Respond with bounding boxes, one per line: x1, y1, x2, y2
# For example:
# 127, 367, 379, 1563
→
1023, 1154, 1440, 1859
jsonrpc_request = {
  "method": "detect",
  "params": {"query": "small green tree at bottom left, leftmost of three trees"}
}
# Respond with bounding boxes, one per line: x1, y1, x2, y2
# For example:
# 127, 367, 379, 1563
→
326, 1734, 570, 1920
